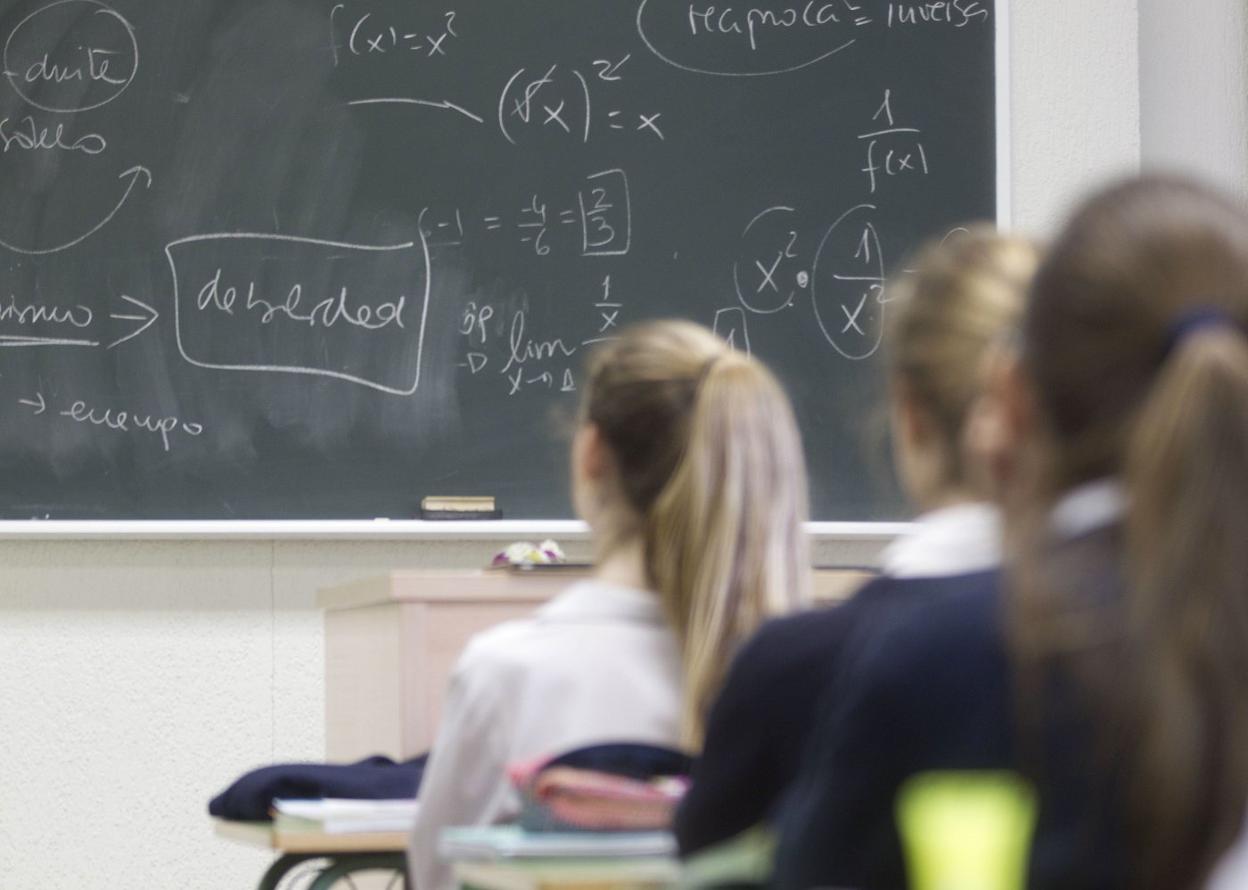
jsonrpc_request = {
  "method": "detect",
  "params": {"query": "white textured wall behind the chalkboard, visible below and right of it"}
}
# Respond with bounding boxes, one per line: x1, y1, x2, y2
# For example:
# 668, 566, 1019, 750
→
0, 0, 1148, 890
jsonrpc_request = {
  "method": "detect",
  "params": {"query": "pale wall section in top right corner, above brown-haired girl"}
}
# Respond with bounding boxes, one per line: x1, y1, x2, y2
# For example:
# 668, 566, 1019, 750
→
1139, 0, 1248, 197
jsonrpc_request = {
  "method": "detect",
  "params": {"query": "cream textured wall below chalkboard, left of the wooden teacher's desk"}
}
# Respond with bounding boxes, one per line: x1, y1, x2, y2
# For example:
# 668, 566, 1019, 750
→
0, 543, 506, 890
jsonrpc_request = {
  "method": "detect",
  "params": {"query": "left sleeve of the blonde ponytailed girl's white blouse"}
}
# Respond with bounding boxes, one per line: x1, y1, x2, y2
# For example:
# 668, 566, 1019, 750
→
408, 649, 519, 890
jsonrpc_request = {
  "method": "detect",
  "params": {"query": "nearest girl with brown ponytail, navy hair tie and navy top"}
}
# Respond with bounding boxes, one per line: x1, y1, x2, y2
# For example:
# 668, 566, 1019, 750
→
778, 178, 1248, 890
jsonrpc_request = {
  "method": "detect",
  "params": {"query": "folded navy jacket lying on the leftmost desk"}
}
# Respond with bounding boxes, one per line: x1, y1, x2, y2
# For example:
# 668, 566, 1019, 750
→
208, 754, 429, 821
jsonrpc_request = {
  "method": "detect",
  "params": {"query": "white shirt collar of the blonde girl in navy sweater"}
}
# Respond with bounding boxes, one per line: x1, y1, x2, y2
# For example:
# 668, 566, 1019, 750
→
881, 503, 1001, 578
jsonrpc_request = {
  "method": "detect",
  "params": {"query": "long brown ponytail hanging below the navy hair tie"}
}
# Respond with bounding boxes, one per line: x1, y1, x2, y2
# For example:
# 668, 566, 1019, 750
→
1126, 323, 1248, 888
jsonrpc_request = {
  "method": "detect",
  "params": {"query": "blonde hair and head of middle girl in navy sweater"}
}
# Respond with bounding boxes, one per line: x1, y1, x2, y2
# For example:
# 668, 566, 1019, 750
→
889, 227, 1040, 509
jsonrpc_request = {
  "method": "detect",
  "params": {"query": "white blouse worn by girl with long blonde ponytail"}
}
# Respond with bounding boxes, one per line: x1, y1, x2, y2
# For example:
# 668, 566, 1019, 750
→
408, 582, 681, 890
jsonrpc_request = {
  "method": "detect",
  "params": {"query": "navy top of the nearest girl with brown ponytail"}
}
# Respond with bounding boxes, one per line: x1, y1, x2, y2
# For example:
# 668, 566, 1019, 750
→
774, 559, 1128, 890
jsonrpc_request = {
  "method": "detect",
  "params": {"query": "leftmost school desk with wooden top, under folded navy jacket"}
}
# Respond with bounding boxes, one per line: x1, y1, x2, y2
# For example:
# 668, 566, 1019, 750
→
213, 819, 407, 890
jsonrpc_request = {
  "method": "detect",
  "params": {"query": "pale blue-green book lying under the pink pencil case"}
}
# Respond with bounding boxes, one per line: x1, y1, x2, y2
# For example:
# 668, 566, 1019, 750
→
438, 825, 676, 861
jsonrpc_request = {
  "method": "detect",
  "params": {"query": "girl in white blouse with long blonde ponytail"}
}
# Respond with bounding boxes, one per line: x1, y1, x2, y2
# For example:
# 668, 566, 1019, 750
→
409, 322, 810, 890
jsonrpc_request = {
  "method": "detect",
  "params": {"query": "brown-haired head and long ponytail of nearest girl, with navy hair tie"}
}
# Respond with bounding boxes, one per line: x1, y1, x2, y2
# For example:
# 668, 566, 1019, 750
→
1007, 178, 1248, 888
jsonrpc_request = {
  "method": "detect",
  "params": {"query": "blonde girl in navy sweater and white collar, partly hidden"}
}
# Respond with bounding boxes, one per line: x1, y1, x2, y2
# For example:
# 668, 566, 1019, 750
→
675, 227, 1040, 856
